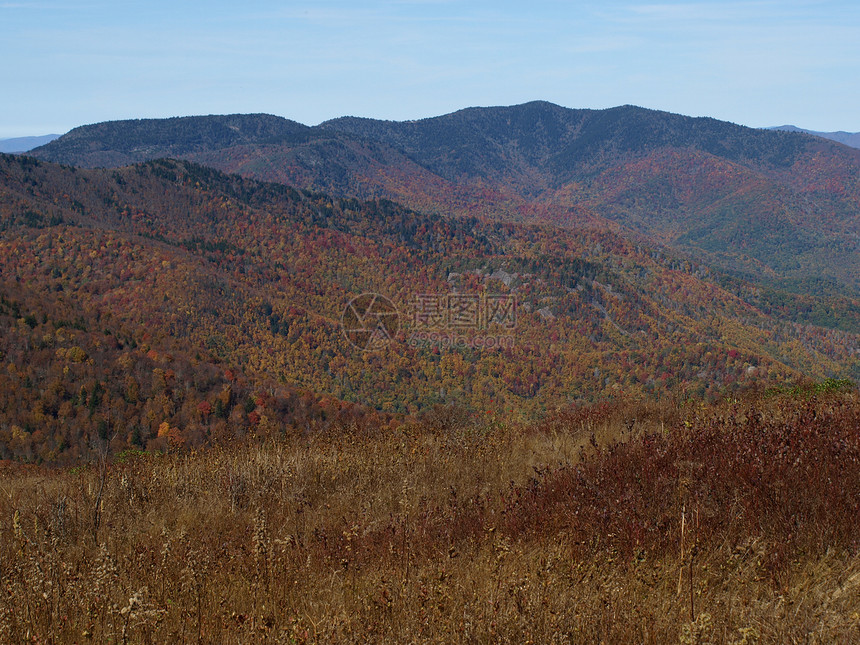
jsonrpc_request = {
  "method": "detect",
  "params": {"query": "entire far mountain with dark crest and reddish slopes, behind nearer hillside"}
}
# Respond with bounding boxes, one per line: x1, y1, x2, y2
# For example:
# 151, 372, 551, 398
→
25, 101, 860, 294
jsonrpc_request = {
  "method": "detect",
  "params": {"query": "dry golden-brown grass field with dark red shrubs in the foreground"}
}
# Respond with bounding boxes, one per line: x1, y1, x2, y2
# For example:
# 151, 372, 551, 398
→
0, 388, 860, 644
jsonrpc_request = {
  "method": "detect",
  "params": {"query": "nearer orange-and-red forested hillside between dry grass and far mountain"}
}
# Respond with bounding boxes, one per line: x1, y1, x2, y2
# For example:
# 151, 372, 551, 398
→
0, 156, 858, 461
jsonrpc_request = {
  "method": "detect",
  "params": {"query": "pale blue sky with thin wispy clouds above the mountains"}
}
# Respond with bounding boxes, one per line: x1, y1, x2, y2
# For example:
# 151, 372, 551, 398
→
0, 0, 860, 138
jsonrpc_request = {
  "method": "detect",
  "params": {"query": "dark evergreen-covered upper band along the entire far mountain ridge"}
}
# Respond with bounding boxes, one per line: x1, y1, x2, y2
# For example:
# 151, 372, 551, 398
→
32, 101, 805, 182
